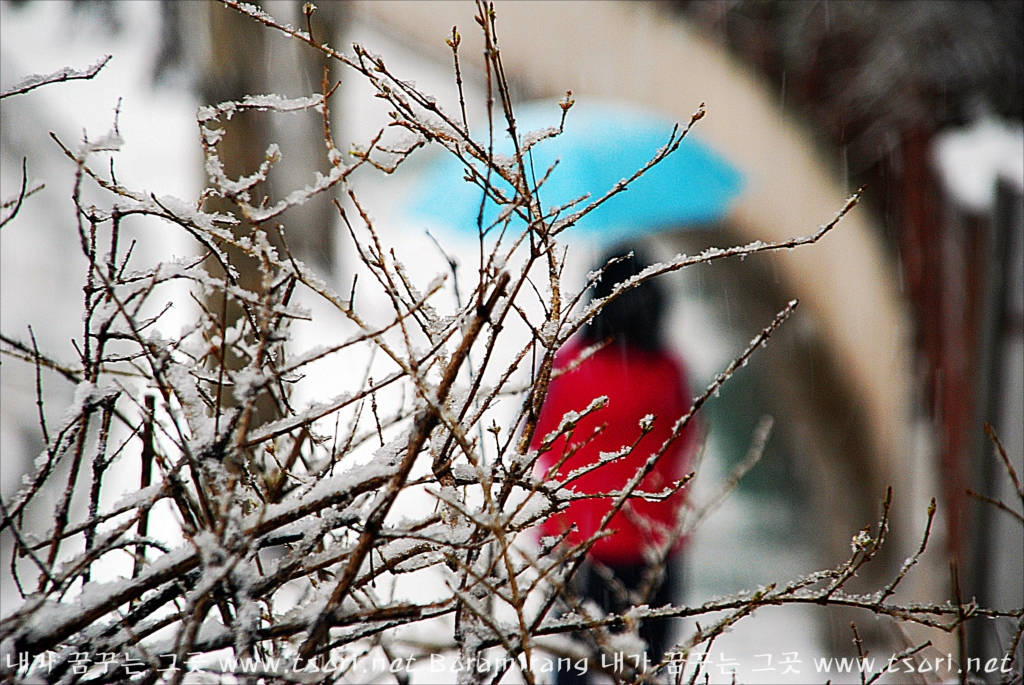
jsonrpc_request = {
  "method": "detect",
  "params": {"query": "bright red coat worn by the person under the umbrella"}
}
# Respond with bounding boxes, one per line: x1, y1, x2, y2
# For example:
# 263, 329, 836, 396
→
532, 339, 696, 565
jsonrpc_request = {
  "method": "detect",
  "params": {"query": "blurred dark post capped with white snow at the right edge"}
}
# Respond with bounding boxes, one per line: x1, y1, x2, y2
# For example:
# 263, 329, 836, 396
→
919, 119, 1024, 667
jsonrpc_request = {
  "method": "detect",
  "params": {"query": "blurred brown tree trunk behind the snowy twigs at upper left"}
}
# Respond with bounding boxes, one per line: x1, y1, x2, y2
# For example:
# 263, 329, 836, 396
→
155, 0, 348, 423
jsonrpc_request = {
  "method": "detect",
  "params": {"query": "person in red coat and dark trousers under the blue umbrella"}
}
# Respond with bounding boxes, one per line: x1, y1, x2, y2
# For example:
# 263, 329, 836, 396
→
532, 247, 696, 683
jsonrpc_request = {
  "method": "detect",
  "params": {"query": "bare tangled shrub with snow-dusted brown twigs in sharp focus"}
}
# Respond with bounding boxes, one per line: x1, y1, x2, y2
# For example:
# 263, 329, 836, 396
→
0, 0, 1024, 683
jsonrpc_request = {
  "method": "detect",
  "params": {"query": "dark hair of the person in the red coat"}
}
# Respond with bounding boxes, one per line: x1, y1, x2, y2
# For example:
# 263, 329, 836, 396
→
583, 246, 665, 350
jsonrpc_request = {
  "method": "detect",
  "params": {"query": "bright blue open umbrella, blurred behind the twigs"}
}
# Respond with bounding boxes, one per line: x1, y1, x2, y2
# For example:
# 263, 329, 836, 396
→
411, 100, 742, 242
